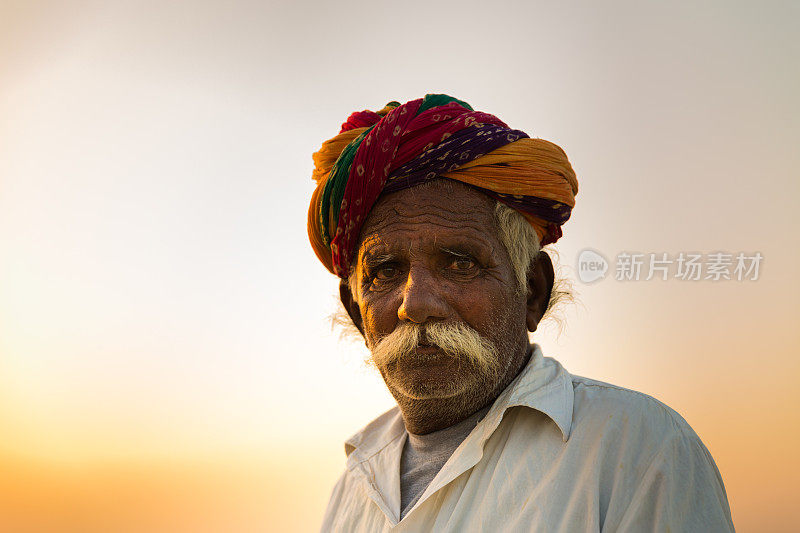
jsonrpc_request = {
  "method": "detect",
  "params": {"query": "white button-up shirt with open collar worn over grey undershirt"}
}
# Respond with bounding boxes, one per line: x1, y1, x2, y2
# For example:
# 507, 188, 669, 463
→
322, 345, 734, 533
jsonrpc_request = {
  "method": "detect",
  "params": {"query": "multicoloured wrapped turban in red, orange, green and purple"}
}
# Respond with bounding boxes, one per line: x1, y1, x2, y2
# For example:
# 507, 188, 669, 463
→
308, 94, 578, 278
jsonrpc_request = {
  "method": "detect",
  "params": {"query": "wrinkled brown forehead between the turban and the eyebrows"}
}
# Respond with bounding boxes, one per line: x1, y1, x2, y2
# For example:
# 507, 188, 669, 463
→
356, 179, 497, 256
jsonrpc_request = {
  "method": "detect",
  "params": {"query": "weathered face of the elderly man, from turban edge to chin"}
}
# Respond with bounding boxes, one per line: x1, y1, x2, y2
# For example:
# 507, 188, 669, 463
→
346, 181, 528, 403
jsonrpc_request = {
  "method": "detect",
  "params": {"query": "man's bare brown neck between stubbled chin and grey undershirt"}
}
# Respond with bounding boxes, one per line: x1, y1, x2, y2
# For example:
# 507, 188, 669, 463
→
390, 345, 533, 435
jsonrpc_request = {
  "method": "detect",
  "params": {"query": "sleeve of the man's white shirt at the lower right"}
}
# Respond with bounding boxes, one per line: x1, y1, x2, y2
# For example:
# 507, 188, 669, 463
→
603, 427, 734, 533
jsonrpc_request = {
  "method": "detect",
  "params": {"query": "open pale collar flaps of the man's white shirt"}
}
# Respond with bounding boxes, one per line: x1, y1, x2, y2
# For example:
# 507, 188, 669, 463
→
344, 344, 574, 465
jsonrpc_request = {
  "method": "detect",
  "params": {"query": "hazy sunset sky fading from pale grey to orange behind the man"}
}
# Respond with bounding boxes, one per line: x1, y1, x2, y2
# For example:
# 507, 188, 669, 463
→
0, 1, 800, 532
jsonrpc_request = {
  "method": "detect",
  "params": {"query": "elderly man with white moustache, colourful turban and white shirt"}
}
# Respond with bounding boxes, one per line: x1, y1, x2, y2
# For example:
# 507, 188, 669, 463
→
309, 95, 733, 532
